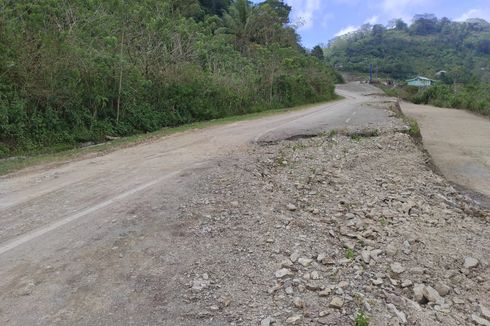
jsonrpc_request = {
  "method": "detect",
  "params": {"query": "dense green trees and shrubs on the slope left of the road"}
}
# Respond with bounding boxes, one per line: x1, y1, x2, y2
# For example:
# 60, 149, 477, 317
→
0, 0, 336, 157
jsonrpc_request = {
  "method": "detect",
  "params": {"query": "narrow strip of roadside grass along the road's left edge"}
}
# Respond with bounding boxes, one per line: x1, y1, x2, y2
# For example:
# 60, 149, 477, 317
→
0, 95, 343, 176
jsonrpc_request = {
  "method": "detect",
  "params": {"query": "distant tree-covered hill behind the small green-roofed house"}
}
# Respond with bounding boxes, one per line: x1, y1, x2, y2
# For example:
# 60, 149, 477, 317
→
326, 14, 490, 83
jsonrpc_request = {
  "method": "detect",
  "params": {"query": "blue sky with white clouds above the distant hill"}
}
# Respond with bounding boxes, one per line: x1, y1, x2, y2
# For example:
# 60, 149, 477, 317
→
253, 0, 490, 48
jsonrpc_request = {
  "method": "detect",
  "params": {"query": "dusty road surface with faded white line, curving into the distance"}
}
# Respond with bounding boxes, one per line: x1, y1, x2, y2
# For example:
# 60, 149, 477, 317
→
0, 84, 402, 325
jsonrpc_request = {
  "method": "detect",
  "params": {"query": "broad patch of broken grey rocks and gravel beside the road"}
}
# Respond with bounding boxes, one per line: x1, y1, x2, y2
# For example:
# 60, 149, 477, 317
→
178, 123, 490, 326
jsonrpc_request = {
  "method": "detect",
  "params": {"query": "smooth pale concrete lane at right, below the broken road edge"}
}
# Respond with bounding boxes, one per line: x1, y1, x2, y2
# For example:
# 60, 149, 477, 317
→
401, 103, 490, 201
